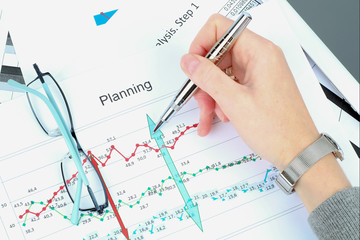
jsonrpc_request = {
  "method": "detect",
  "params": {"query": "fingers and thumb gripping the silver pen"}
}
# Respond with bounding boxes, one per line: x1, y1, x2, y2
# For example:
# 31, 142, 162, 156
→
181, 14, 276, 136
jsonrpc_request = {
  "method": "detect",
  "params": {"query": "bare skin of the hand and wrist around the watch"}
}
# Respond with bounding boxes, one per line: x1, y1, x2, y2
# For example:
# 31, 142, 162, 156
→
181, 15, 351, 212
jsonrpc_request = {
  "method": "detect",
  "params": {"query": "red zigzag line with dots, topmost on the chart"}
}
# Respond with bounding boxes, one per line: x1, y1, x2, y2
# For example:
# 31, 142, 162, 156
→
19, 123, 198, 219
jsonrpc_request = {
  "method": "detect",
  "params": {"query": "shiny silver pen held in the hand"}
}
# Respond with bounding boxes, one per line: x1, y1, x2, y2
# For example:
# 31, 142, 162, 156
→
153, 12, 251, 133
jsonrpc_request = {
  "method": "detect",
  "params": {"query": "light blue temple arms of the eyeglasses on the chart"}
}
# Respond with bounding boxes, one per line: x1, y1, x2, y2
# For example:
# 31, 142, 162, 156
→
8, 79, 89, 224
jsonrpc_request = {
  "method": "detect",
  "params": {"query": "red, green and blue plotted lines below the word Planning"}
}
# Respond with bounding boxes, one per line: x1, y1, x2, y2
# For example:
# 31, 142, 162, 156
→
11, 112, 277, 239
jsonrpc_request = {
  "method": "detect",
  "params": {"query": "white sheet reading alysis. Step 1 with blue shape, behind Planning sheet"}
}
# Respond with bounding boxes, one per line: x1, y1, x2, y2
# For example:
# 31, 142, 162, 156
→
5, 0, 232, 82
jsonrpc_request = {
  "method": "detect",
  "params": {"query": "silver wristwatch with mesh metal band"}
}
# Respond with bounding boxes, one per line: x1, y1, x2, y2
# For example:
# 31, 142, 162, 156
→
276, 133, 344, 194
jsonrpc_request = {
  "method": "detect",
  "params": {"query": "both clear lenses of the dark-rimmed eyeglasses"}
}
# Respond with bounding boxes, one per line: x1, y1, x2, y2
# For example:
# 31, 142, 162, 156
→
27, 69, 108, 213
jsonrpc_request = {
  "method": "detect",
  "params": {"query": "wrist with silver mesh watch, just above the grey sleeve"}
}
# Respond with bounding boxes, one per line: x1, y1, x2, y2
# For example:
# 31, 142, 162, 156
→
276, 134, 350, 212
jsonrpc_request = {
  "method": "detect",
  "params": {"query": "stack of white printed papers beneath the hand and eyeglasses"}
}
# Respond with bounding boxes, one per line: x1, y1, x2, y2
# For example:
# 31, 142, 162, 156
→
0, 0, 359, 239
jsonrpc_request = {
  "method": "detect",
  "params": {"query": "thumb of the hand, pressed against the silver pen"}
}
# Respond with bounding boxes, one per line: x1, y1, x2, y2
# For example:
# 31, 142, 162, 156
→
181, 54, 240, 107
